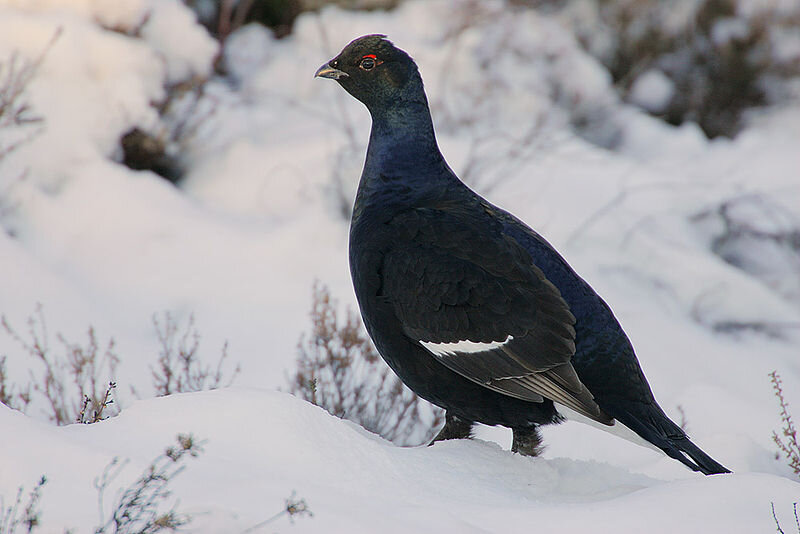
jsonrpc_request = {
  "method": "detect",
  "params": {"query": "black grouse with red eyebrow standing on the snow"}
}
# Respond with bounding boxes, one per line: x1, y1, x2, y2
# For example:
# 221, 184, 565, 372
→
316, 35, 729, 475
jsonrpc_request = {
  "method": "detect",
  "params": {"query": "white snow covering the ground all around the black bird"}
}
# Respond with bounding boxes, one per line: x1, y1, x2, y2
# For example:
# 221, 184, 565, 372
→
0, 0, 800, 533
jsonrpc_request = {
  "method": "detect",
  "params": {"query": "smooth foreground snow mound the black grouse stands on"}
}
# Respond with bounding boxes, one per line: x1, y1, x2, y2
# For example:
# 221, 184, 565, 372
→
0, 389, 800, 533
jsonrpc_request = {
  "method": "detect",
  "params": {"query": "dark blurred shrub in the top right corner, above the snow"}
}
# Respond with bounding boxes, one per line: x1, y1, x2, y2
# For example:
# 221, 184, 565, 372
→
574, 0, 800, 137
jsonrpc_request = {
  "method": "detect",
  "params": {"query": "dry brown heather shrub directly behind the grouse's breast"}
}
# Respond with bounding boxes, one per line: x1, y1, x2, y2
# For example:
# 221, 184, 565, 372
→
289, 282, 442, 445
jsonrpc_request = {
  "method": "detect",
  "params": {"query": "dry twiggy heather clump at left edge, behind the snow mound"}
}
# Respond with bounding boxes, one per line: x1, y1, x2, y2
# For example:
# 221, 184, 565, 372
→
0, 305, 119, 425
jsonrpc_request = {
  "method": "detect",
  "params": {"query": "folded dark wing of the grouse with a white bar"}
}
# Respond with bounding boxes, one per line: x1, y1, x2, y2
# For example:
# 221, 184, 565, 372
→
379, 206, 611, 424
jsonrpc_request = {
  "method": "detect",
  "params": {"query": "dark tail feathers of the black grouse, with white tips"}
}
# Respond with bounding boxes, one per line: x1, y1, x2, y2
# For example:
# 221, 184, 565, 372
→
615, 404, 731, 475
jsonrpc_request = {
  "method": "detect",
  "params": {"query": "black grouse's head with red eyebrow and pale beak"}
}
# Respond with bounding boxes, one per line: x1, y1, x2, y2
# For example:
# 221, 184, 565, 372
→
315, 35, 424, 111
